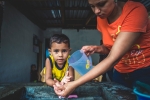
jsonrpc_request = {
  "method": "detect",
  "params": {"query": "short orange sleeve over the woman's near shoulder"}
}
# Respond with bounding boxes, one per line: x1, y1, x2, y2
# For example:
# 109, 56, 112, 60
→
121, 3, 148, 32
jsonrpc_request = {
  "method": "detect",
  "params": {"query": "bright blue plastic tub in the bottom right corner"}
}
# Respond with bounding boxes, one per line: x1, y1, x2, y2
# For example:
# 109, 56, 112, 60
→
133, 88, 150, 100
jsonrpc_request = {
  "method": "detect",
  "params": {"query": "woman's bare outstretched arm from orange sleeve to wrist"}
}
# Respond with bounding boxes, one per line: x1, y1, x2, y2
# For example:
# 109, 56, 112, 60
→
76, 32, 141, 86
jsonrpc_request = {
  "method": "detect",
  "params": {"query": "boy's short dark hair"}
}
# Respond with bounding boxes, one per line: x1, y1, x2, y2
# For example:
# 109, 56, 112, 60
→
49, 34, 70, 48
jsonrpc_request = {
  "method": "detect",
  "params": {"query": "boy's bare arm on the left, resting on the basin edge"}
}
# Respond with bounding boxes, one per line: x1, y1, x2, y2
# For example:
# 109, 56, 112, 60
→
45, 58, 55, 86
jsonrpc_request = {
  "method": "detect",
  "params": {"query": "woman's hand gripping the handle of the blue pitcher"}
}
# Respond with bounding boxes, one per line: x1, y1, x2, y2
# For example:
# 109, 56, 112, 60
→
81, 45, 97, 56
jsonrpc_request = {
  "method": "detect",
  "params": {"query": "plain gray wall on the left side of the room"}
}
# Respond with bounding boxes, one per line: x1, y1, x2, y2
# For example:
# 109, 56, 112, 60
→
0, 2, 42, 83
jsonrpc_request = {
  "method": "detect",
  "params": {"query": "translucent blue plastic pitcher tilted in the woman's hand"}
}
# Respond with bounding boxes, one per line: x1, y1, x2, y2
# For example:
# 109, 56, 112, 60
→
68, 50, 93, 75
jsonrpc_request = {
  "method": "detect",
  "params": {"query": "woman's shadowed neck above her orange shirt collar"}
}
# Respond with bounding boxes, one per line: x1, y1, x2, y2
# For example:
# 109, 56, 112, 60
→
107, 2, 125, 24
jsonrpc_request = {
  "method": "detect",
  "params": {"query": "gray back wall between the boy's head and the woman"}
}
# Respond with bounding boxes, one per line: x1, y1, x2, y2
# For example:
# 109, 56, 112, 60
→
62, 29, 101, 65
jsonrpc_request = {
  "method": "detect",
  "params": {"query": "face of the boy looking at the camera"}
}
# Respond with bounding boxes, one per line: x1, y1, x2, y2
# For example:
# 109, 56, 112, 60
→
50, 42, 70, 66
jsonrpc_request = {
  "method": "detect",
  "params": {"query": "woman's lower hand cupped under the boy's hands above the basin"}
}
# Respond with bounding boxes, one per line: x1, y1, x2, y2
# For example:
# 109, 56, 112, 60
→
53, 81, 76, 97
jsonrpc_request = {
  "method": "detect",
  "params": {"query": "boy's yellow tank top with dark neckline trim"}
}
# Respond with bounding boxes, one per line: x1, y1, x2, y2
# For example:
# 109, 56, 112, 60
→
50, 55, 69, 81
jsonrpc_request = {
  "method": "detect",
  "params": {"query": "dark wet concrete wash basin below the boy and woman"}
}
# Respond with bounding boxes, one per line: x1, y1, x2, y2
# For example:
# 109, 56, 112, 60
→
0, 82, 136, 100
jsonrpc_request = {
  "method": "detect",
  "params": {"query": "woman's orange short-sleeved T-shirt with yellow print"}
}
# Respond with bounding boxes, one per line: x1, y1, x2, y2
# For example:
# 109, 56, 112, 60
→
97, 1, 150, 73
